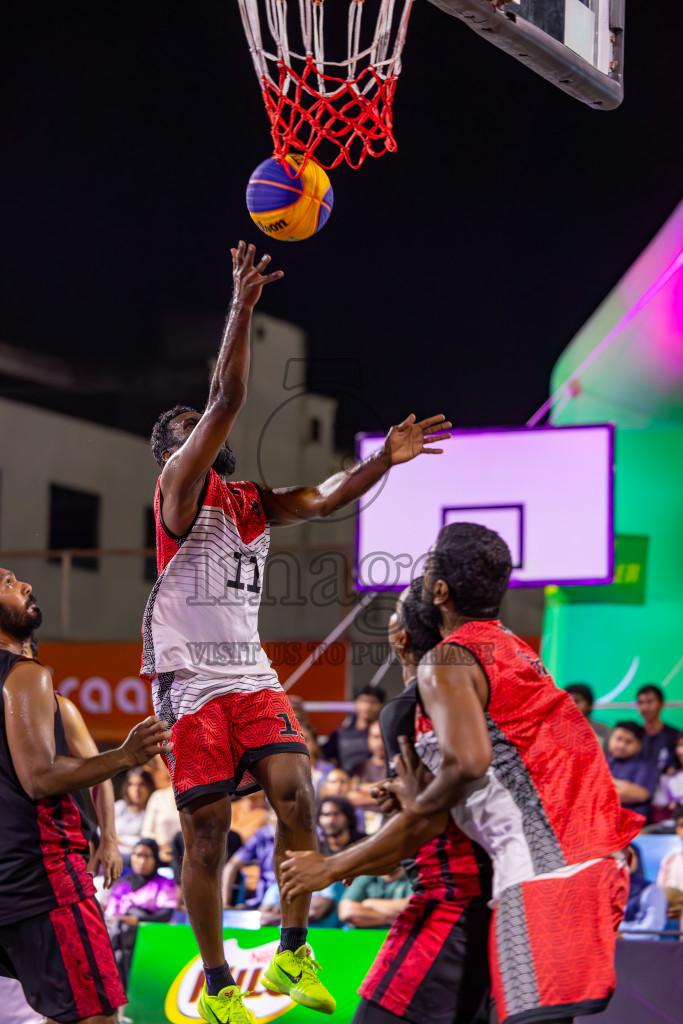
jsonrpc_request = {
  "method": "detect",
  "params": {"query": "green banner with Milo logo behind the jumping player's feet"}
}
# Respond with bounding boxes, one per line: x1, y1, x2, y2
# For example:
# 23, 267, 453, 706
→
124, 925, 386, 1024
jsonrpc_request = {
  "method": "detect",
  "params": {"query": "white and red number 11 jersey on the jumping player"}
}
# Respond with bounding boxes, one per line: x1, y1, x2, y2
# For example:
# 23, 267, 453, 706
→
141, 469, 281, 724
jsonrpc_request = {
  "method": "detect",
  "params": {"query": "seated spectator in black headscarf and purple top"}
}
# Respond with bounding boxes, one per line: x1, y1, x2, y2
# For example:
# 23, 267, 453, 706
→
104, 839, 175, 988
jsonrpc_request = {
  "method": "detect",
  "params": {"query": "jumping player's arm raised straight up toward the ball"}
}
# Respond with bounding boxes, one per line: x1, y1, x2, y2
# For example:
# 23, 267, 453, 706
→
161, 242, 283, 537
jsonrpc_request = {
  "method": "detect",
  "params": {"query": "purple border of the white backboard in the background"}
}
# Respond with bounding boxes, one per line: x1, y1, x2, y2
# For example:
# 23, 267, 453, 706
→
353, 423, 615, 594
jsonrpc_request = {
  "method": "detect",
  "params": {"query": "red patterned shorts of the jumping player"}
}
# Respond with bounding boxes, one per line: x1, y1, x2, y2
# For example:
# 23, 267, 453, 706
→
165, 690, 308, 808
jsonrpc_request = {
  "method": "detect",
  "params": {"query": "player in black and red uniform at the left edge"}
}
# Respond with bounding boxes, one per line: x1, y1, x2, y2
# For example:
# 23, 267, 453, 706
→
0, 569, 171, 1024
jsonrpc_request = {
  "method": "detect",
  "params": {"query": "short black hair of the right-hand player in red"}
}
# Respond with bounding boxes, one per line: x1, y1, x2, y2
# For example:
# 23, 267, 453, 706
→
432, 522, 512, 618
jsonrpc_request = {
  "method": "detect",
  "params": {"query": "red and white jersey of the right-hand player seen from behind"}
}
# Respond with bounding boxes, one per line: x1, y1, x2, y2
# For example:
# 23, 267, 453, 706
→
416, 620, 643, 897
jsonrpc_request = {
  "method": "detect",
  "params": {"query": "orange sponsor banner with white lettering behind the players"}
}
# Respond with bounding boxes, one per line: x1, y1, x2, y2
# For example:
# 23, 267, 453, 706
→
38, 640, 349, 743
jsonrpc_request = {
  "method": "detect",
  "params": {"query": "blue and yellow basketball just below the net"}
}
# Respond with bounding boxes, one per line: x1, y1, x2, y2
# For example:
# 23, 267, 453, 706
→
247, 154, 334, 242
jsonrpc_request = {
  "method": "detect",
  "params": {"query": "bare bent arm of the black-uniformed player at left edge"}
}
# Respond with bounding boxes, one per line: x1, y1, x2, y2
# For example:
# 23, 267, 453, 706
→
3, 662, 172, 800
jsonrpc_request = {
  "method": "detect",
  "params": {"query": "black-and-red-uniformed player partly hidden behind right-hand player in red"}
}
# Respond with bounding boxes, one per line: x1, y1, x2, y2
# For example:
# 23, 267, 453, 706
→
283, 580, 492, 1024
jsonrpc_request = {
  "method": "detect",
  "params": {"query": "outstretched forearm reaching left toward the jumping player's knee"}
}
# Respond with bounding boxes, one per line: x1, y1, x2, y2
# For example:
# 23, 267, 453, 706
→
327, 811, 445, 881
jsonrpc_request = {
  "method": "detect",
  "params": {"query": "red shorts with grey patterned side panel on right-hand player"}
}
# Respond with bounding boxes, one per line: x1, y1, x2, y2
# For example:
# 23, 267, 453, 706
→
489, 857, 629, 1024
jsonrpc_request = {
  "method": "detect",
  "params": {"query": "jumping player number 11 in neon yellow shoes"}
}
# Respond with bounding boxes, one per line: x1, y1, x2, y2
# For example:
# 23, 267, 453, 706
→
142, 242, 451, 1024
